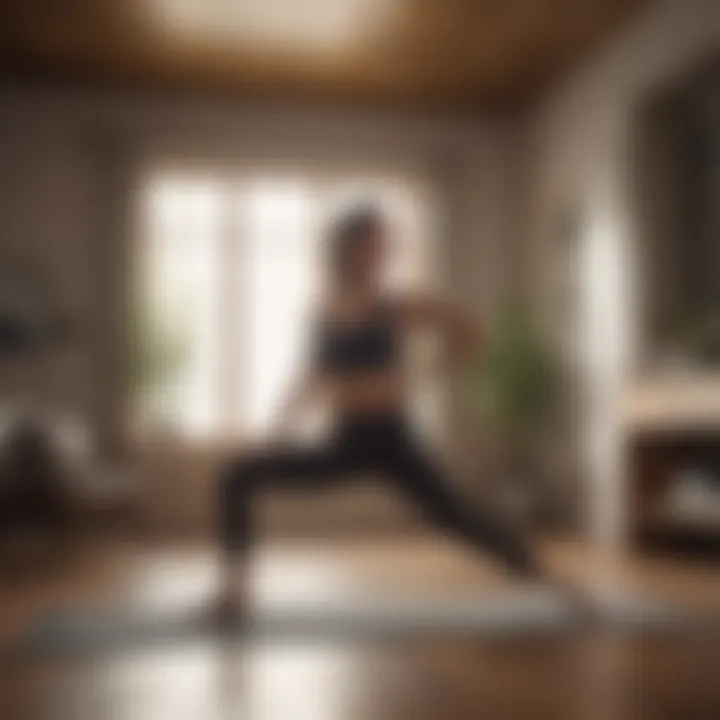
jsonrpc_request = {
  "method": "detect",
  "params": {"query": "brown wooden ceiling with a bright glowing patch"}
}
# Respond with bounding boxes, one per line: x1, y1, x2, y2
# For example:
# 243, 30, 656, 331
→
0, 0, 647, 107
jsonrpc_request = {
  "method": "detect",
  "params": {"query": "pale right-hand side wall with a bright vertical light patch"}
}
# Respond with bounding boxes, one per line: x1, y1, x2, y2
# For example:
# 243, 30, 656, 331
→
526, 0, 720, 548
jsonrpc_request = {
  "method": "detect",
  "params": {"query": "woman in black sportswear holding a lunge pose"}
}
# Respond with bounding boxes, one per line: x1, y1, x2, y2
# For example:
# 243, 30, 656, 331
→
219, 202, 576, 611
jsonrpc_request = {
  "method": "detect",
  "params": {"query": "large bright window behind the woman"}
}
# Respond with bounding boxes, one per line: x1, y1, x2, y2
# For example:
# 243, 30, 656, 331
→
133, 170, 442, 439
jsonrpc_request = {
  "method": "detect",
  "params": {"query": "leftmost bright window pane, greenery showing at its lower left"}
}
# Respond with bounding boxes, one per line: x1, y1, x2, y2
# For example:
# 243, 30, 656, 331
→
135, 177, 222, 435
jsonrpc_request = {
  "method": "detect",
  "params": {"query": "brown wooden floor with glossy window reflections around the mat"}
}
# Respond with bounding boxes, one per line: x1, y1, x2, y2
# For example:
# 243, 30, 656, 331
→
0, 537, 720, 720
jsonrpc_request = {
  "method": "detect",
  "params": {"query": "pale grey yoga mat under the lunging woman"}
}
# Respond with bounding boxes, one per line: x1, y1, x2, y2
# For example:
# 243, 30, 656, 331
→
20, 590, 695, 653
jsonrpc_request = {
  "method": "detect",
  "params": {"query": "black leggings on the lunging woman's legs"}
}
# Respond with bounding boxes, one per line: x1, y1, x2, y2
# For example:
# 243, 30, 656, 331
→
219, 415, 536, 574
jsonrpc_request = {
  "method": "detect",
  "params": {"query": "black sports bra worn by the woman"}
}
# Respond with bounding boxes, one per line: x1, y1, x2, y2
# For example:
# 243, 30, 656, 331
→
315, 305, 401, 375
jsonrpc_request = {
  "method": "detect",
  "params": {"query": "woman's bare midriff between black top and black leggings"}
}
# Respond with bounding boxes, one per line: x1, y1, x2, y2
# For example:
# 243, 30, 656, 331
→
323, 371, 406, 415
